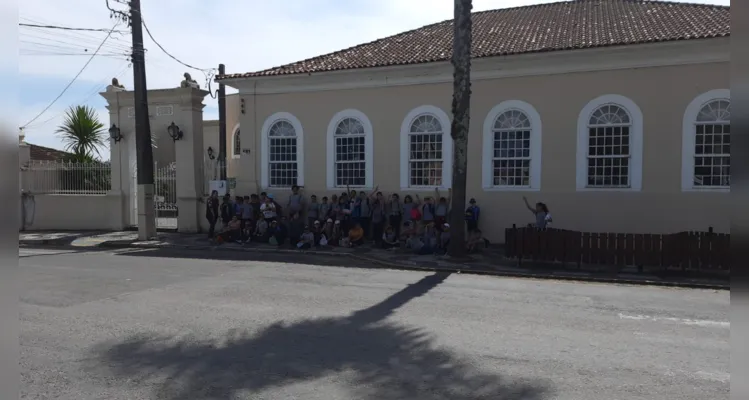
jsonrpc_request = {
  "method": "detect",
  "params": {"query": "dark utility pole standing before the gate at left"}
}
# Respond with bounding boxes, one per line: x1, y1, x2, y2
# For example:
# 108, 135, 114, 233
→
130, 0, 156, 240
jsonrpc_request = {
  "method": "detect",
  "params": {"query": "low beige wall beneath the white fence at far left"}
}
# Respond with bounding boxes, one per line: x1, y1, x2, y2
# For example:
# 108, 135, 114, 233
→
21, 195, 124, 231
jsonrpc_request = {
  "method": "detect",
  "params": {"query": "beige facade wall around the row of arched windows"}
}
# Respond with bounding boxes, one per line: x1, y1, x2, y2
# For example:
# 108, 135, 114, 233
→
229, 63, 729, 240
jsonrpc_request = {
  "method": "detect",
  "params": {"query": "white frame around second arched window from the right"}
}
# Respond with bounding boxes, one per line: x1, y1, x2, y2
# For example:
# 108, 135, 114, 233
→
576, 94, 643, 192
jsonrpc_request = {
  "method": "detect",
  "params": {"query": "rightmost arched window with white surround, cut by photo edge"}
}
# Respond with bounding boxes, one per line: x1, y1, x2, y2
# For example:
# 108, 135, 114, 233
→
682, 90, 731, 190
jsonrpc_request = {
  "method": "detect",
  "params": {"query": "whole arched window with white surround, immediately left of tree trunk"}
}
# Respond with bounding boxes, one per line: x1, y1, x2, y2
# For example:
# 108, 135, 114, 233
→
401, 106, 453, 190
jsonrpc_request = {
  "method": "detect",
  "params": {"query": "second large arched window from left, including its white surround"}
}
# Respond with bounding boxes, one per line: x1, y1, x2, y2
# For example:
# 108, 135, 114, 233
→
328, 110, 373, 188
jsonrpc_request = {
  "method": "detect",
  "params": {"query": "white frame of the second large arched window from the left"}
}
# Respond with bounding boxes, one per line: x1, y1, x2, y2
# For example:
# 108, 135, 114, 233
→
327, 109, 374, 190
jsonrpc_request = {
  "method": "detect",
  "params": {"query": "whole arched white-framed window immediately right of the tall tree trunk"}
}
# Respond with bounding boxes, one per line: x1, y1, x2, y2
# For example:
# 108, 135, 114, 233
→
482, 100, 541, 190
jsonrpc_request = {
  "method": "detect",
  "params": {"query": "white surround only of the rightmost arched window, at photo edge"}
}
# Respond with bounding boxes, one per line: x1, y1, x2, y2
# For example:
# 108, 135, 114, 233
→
681, 89, 733, 192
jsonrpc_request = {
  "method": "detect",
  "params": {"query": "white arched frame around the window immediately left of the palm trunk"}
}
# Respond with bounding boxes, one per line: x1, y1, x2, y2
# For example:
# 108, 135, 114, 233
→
400, 105, 453, 192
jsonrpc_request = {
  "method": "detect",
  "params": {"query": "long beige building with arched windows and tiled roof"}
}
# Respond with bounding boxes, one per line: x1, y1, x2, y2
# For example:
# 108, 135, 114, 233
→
217, 0, 730, 239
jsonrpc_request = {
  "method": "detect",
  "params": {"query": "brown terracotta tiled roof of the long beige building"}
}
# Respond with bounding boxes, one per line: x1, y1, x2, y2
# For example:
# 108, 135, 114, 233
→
216, 0, 731, 80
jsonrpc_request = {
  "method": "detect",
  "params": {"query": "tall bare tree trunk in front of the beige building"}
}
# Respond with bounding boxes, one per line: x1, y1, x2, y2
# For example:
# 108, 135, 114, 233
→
448, 0, 473, 257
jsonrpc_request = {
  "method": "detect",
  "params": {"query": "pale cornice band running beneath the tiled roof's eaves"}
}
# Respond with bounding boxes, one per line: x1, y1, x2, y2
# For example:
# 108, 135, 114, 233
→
222, 38, 730, 94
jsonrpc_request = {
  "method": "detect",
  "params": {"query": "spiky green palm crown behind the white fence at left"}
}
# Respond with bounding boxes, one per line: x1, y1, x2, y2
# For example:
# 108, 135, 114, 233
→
55, 106, 106, 162
